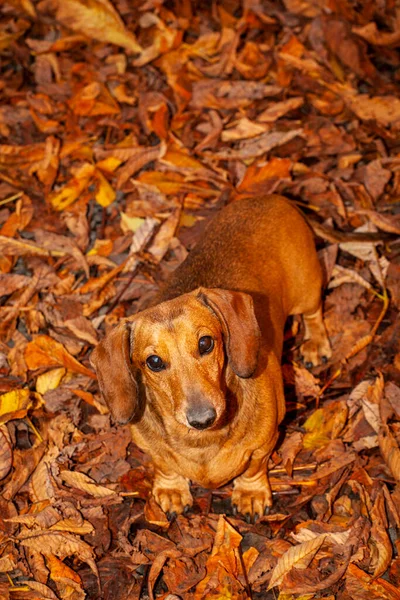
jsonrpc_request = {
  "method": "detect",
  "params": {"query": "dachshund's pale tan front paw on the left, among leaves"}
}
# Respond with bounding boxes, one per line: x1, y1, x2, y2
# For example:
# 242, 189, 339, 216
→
152, 468, 193, 520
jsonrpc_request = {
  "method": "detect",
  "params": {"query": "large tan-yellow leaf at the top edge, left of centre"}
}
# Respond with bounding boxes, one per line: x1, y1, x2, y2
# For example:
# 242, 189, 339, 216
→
52, 0, 142, 54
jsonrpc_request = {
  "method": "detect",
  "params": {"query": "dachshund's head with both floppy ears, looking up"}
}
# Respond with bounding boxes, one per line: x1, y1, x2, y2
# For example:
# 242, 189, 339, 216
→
91, 288, 260, 430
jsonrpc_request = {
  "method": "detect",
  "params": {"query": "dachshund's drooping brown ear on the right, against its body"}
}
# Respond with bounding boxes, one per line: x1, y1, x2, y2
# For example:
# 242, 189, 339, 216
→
196, 288, 260, 378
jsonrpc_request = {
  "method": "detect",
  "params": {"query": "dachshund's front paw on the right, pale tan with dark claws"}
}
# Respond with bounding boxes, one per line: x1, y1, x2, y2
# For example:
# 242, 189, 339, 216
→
232, 474, 272, 523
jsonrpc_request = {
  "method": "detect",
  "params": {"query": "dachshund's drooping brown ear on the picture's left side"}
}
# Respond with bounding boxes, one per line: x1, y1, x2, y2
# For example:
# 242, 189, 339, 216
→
90, 322, 138, 424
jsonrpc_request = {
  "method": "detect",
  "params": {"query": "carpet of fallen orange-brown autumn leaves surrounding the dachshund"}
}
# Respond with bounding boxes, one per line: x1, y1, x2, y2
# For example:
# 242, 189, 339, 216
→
0, 0, 400, 600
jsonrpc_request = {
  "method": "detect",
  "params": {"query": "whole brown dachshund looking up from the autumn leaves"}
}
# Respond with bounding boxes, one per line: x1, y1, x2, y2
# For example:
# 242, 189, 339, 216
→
91, 196, 331, 519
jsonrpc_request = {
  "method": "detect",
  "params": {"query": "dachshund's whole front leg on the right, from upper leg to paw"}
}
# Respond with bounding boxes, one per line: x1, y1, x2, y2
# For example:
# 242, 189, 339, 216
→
232, 444, 275, 523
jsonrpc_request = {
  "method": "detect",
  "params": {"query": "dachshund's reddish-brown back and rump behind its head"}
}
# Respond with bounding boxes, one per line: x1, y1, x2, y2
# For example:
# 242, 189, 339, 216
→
157, 195, 321, 352
